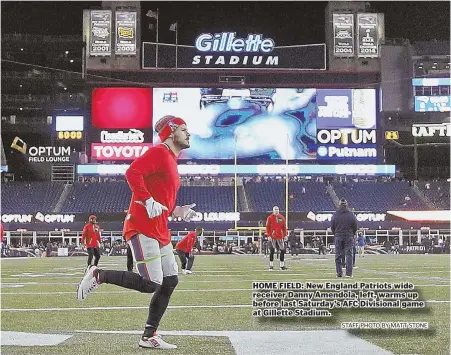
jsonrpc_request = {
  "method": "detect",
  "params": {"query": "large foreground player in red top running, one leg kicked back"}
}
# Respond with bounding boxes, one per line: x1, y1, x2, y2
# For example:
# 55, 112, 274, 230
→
77, 116, 196, 349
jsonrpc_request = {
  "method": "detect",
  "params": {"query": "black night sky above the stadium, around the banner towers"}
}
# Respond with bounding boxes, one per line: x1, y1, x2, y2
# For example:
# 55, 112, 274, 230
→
1, 1, 450, 45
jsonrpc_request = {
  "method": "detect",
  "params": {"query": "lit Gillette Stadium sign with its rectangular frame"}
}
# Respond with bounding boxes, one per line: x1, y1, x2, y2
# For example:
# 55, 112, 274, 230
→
142, 31, 326, 70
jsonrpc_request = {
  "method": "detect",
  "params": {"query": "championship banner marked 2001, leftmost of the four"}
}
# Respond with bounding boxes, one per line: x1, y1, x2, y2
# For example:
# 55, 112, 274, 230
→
89, 10, 112, 57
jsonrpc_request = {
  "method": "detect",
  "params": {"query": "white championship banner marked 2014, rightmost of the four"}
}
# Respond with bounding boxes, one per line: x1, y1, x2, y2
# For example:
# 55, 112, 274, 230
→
357, 14, 379, 58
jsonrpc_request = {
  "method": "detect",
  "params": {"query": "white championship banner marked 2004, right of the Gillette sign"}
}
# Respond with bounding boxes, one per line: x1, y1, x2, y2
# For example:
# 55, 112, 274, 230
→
333, 14, 354, 57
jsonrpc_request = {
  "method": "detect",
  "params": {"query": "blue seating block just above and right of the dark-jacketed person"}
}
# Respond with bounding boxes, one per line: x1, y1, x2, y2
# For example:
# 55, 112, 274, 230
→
333, 181, 427, 211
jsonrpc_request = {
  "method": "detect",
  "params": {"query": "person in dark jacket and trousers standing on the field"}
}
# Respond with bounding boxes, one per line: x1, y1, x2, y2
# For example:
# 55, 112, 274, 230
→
331, 198, 357, 277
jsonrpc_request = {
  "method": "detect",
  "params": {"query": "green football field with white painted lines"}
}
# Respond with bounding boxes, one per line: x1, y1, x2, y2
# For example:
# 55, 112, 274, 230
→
1, 255, 450, 355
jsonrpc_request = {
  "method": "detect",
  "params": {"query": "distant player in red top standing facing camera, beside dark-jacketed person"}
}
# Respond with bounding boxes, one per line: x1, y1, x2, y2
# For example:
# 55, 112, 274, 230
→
266, 206, 287, 271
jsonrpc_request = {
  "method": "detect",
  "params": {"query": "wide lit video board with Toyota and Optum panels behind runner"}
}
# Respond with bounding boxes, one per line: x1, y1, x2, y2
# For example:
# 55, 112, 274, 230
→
91, 88, 378, 162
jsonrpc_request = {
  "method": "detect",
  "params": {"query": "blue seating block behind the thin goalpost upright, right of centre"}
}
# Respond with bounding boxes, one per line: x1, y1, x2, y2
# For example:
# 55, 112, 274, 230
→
245, 181, 335, 212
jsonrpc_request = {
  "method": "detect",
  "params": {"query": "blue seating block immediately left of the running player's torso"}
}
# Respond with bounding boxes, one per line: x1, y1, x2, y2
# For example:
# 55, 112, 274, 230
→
61, 181, 132, 213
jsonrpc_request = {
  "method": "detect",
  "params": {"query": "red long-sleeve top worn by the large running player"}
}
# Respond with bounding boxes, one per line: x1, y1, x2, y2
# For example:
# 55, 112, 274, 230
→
123, 144, 180, 247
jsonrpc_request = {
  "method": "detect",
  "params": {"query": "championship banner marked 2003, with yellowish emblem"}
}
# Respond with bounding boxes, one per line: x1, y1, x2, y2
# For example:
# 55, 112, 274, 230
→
115, 11, 137, 55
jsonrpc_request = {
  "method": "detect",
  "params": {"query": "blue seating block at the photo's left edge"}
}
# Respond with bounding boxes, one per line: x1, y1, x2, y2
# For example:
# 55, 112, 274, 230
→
2, 182, 64, 213
